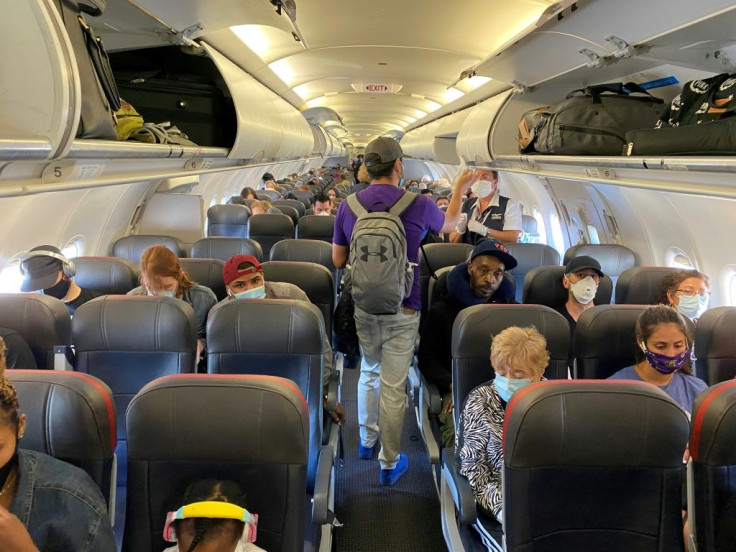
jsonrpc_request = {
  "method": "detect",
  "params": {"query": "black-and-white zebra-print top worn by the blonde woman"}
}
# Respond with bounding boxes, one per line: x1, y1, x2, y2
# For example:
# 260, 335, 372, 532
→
460, 384, 504, 517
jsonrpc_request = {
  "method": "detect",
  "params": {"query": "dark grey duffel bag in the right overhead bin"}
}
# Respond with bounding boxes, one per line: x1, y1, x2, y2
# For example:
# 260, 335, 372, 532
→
519, 82, 665, 155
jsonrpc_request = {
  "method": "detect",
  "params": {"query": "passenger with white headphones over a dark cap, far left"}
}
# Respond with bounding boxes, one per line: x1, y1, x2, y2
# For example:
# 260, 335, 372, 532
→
20, 245, 102, 314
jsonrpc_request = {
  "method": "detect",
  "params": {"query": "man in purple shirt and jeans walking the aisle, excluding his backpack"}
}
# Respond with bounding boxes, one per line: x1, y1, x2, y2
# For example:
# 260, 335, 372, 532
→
332, 138, 476, 485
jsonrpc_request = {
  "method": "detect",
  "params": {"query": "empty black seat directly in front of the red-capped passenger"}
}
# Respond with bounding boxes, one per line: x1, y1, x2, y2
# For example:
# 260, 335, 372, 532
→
207, 299, 325, 492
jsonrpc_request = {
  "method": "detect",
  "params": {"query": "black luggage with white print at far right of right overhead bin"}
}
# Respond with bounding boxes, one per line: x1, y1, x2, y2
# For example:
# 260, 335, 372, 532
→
626, 73, 736, 155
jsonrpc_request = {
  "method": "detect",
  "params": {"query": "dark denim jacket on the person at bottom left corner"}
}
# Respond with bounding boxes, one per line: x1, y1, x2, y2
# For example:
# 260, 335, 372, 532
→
10, 449, 117, 552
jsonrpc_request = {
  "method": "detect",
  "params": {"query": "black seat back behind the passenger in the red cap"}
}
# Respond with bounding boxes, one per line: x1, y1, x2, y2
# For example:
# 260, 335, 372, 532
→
263, 261, 335, 334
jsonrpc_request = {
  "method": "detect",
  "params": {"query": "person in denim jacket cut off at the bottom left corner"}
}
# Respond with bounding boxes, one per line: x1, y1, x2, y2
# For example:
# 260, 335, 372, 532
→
0, 339, 116, 552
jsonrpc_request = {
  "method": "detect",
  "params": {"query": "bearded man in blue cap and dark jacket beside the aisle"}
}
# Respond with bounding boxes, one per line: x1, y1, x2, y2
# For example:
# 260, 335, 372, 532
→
419, 239, 517, 443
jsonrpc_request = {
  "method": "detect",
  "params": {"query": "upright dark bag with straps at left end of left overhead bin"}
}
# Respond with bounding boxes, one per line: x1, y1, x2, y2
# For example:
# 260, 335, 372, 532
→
55, 0, 120, 140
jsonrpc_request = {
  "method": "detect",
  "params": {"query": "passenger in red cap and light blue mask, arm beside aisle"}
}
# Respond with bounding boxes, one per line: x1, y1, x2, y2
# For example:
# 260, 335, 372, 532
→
222, 255, 345, 423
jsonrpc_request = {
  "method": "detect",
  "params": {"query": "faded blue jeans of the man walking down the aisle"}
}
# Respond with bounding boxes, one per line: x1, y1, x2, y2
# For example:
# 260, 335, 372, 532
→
355, 307, 419, 469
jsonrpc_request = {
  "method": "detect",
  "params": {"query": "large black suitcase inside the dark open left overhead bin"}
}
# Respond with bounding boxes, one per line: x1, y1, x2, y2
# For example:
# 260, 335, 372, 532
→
110, 46, 237, 148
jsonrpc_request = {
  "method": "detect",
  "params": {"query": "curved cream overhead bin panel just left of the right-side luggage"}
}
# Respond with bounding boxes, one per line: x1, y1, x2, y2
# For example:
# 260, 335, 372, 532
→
457, 90, 516, 165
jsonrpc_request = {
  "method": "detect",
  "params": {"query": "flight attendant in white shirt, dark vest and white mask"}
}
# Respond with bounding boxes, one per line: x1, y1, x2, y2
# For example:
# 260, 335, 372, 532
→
450, 169, 522, 245
